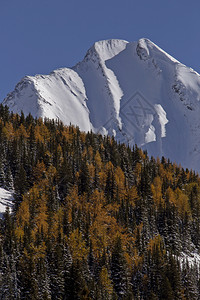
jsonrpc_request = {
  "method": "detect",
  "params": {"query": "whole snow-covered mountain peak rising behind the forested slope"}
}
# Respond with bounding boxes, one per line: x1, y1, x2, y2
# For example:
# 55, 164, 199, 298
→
3, 39, 200, 171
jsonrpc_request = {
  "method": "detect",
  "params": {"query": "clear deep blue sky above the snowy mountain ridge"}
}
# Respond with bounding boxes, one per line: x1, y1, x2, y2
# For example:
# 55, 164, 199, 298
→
0, 0, 200, 101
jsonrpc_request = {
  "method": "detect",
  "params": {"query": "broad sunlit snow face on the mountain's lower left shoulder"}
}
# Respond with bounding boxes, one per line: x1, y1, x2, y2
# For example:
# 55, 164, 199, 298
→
4, 68, 92, 131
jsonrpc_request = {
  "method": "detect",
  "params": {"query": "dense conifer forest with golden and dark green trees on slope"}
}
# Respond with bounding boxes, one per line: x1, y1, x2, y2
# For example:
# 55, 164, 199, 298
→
0, 105, 200, 300
